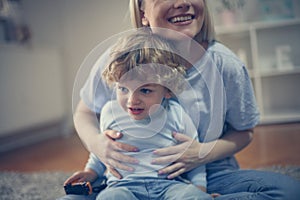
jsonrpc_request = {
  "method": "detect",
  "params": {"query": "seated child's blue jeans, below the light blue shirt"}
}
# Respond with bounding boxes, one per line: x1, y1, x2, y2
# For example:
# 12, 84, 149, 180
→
97, 178, 212, 200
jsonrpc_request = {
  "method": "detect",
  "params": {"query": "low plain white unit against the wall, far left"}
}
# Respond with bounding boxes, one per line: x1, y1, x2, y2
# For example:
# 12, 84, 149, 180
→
0, 46, 66, 136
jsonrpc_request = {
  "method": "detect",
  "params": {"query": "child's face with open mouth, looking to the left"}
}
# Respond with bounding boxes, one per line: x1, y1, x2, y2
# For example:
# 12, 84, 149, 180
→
117, 80, 171, 120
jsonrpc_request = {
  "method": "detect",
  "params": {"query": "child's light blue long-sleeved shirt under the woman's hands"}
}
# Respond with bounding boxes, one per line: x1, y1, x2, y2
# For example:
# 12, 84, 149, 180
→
86, 100, 206, 187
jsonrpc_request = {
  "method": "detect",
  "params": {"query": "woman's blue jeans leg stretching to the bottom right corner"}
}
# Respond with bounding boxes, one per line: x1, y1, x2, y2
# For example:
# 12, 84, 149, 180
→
207, 169, 300, 200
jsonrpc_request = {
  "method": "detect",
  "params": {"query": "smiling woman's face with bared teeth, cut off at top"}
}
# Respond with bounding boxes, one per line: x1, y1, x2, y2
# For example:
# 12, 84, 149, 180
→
142, 0, 204, 39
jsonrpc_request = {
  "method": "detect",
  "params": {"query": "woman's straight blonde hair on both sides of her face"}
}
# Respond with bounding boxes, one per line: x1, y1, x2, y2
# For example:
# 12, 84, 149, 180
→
129, 0, 215, 43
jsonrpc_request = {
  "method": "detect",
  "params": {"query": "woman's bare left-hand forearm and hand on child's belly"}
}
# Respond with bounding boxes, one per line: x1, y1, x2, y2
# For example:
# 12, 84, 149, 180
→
74, 101, 137, 178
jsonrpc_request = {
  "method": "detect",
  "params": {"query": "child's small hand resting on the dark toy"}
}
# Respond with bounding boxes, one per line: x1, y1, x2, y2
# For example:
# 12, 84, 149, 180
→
64, 169, 98, 185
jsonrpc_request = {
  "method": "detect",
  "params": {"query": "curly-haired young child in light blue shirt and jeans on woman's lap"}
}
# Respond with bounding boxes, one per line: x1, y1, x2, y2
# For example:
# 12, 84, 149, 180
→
60, 30, 212, 199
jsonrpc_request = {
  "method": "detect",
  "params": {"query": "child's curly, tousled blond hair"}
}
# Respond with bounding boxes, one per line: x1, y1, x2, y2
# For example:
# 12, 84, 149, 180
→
102, 28, 186, 94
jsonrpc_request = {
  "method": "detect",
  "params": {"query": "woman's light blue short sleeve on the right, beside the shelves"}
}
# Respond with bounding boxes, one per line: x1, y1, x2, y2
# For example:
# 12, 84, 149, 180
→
211, 43, 259, 130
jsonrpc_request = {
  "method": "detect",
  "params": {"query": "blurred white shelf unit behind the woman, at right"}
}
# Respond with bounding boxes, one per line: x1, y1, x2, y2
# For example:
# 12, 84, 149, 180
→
216, 19, 300, 124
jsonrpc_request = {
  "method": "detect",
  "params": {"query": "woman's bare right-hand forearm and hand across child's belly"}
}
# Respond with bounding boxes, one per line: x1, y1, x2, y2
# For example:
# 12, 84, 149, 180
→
153, 129, 253, 179
